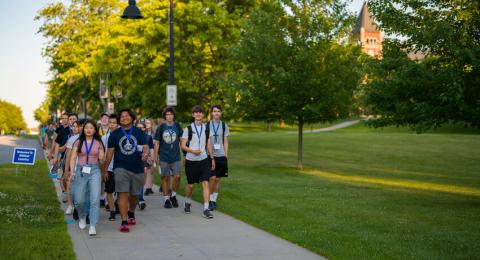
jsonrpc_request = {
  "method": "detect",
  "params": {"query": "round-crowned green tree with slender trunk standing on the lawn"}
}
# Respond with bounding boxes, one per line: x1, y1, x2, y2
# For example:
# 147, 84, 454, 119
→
231, 0, 361, 169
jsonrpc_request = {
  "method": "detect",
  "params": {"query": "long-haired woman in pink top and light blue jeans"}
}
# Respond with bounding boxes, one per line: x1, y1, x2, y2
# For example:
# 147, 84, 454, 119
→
70, 120, 105, 236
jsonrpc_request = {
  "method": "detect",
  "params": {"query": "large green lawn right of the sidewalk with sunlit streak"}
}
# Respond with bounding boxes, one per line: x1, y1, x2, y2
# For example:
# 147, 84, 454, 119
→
162, 124, 480, 259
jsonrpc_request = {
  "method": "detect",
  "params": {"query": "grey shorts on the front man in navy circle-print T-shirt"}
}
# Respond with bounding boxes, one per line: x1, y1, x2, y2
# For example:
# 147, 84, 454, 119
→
113, 168, 145, 196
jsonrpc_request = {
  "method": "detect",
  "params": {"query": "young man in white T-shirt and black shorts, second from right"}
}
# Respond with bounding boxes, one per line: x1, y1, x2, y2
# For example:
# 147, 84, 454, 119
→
181, 106, 215, 218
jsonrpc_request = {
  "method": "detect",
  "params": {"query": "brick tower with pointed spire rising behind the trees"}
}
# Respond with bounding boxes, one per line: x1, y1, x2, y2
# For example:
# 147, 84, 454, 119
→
354, 2, 382, 58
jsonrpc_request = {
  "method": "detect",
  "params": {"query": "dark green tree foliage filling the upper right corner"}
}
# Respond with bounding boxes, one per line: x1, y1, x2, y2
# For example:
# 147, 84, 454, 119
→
365, 0, 480, 132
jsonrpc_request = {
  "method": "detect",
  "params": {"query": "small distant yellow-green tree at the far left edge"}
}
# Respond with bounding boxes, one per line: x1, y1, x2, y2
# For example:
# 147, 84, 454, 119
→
0, 100, 27, 134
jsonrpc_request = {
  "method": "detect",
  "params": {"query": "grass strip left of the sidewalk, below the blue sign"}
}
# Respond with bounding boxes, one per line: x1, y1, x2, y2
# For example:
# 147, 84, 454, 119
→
0, 161, 75, 259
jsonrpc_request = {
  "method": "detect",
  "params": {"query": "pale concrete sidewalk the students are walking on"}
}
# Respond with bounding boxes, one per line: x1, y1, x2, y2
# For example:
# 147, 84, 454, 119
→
49, 165, 323, 260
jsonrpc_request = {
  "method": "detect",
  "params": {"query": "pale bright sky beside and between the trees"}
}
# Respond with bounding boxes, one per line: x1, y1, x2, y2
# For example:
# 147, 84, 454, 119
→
0, 0, 363, 128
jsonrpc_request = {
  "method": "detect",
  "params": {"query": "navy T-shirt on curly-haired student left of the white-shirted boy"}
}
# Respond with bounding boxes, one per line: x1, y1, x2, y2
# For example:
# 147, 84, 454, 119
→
155, 122, 183, 163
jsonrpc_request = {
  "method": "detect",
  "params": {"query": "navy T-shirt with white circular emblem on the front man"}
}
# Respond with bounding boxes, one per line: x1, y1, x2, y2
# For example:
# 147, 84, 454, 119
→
108, 126, 147, 174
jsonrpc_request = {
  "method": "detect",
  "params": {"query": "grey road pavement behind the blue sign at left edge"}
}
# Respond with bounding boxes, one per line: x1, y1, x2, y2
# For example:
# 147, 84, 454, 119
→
0, 135, 44, 163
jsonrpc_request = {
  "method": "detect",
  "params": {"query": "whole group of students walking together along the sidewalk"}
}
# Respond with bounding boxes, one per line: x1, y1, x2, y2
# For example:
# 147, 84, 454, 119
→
44, 105, 229, 236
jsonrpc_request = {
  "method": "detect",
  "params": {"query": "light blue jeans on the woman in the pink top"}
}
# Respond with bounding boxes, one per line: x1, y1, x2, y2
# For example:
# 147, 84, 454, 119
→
72, 164, 102, 226
